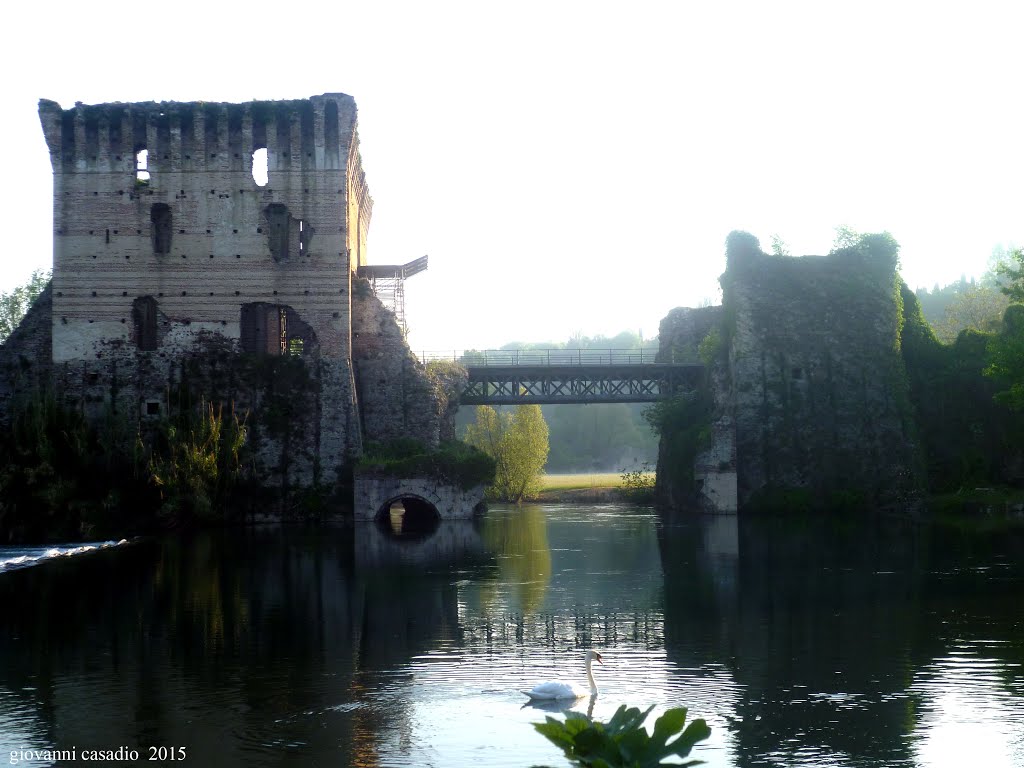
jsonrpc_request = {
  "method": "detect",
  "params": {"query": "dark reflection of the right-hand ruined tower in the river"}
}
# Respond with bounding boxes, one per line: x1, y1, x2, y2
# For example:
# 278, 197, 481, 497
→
732, 519, 921, 765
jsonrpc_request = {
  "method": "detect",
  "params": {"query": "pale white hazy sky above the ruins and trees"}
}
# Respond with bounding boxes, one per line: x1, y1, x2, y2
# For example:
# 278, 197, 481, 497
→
0, 0, 1024, 349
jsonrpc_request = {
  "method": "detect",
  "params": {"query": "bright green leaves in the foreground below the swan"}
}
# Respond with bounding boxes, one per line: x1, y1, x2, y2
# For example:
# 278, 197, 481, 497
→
534, 705, 711, 768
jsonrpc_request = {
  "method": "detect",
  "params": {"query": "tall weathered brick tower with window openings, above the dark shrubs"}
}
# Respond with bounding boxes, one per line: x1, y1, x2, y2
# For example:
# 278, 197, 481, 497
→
0, 93, 438, 493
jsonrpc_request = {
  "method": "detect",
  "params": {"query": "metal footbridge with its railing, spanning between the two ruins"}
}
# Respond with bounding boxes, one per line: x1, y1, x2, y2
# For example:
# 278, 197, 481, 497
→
421, 349, 703, 406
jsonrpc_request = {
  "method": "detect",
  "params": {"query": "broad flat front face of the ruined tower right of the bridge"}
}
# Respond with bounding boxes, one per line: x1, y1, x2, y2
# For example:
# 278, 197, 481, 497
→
723, 237, 922, 505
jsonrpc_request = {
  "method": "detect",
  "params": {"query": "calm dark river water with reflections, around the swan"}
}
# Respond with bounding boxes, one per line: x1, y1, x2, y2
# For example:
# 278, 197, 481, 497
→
0, 506, 1024, 768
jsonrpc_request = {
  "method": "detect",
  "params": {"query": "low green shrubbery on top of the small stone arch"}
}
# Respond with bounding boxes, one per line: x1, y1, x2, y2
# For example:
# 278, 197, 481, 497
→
357, 437, 495, 490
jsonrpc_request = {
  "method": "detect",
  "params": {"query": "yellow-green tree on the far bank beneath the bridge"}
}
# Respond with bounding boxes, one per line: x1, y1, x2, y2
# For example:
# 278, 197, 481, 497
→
466, 406, 548, 503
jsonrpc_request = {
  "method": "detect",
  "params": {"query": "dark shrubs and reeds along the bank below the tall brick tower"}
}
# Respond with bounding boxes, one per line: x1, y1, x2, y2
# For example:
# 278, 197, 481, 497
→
0, 391, 253, 542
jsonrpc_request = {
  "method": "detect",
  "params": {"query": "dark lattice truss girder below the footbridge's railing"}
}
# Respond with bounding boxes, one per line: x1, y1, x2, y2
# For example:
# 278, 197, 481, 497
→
459, 364, 703, 406
